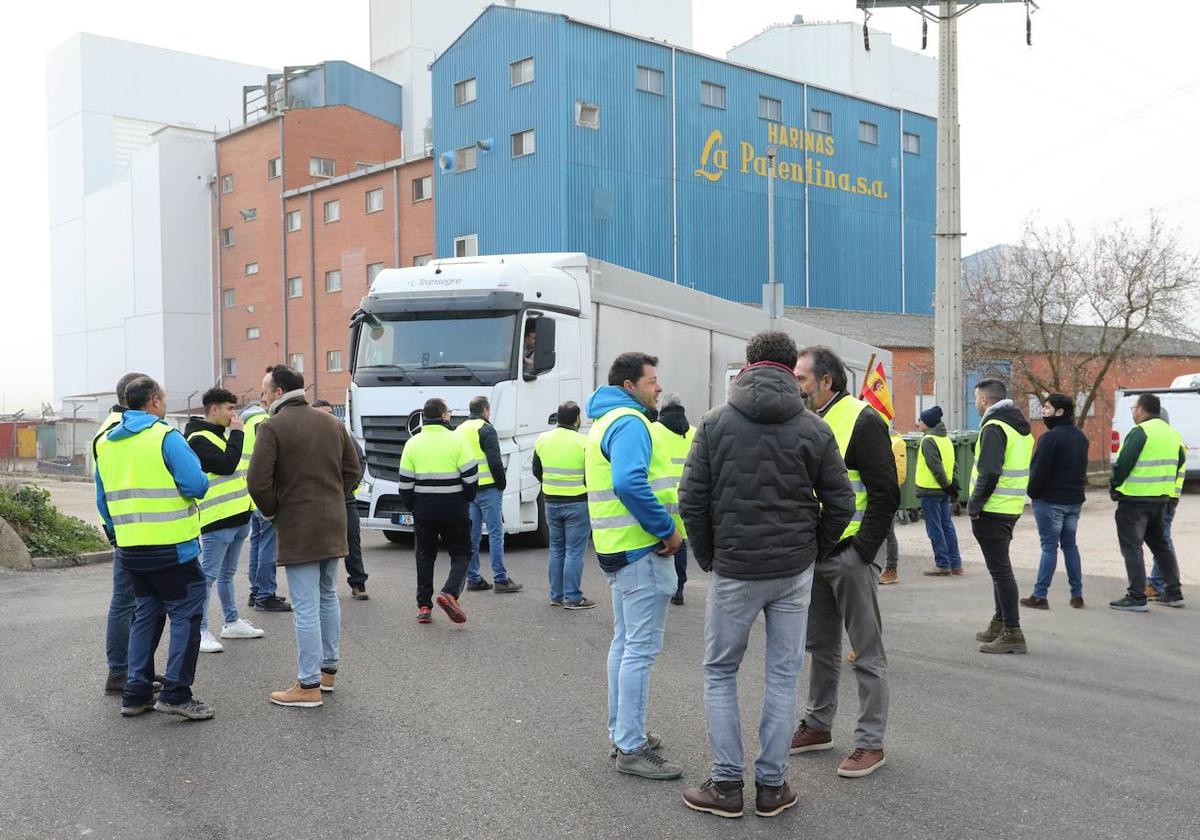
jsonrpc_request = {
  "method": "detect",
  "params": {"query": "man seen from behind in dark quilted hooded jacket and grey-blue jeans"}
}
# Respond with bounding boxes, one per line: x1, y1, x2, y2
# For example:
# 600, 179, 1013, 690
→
681, 332, 859, 816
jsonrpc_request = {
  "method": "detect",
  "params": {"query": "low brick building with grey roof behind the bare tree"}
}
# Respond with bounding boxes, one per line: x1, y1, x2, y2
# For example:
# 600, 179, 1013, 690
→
788, 310, 1200, 469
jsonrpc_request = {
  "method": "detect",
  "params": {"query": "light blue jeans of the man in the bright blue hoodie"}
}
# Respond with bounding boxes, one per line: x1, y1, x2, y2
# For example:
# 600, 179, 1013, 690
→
607, 552, 676, 752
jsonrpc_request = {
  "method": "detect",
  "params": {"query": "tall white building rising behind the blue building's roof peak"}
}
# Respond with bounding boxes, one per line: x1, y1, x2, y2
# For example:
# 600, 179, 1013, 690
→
371, 0, 691, 156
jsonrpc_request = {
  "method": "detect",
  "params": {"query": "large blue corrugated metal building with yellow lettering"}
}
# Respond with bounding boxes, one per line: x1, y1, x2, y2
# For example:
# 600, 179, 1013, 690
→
432, 6, 936, 313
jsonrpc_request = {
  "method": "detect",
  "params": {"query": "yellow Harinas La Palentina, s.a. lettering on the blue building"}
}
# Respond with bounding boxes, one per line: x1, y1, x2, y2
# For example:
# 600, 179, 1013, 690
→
692, 122, 888, 200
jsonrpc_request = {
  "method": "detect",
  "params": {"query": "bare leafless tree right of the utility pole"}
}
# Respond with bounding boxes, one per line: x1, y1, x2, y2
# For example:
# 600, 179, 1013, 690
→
962, 216, 1200, 425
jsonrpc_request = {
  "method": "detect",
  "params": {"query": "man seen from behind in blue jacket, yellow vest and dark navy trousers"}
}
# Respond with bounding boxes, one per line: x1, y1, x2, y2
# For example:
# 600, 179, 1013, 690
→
96, 377, 212, 720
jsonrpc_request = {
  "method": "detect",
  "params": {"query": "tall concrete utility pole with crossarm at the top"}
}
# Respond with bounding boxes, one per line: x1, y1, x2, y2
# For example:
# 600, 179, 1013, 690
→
857, 0, 1037, 430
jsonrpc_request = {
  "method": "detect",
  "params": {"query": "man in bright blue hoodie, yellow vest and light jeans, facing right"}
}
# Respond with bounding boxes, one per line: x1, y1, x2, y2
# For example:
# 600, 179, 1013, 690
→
584, 353, 683, 779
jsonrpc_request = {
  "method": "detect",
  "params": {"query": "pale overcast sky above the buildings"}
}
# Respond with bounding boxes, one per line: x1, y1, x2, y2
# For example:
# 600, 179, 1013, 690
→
0, 0, 1200, 414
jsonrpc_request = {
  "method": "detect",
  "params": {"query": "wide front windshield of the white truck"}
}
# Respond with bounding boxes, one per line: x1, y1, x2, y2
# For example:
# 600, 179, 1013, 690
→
354, 312, 517, 384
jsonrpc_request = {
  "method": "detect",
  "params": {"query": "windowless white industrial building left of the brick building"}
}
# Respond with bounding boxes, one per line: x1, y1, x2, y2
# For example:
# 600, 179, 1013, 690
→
47, 34, 270, 416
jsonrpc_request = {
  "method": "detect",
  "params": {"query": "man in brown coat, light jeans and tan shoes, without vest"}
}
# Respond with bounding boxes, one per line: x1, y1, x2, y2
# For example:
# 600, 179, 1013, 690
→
247, 365, 359, 708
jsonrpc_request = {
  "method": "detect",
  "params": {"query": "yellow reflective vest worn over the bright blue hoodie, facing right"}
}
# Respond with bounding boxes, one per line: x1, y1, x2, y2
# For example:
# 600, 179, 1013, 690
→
584, 408, 679, 554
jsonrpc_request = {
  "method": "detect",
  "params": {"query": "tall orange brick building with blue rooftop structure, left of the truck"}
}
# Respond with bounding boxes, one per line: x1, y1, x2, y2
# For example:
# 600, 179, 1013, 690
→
214, 62, 433, 404
